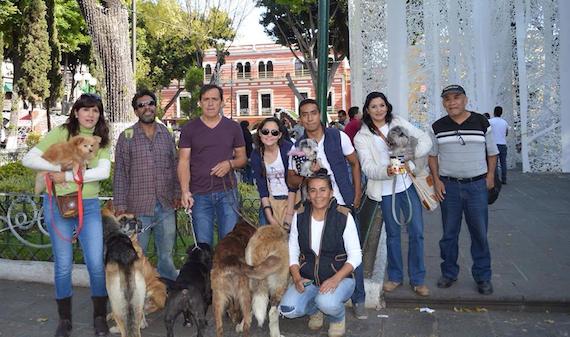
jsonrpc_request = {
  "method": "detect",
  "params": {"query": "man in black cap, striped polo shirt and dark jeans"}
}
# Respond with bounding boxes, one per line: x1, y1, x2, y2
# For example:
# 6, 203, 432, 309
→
429, 85, 499, 295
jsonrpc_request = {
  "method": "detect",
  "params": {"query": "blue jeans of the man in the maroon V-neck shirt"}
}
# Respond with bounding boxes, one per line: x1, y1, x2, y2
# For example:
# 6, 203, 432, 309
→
192, 188, 239, 247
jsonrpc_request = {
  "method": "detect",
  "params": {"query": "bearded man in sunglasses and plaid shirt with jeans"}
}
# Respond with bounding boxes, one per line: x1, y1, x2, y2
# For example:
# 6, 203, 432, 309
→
113, 89, 180, 280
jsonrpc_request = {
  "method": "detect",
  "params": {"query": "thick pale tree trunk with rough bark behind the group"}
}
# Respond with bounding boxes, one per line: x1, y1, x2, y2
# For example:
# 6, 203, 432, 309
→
77, 0, 135, 144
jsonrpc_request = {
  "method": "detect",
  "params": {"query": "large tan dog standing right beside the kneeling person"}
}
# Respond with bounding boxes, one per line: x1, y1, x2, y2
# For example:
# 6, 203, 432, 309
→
245, 225, 289, 337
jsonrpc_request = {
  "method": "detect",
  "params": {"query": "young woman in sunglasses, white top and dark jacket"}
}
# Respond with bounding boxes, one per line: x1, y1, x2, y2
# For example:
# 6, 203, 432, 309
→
251, 117, 295, 228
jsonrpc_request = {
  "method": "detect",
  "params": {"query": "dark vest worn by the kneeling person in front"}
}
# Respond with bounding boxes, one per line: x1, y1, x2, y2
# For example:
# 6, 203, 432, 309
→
297, 198, 352, 286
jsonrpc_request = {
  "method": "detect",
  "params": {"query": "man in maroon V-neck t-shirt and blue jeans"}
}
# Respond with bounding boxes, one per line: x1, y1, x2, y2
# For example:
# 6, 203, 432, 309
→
178, 84, 247, 246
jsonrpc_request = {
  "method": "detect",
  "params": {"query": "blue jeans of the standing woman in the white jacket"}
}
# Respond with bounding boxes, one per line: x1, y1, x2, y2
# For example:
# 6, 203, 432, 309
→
380, 185, 426, 286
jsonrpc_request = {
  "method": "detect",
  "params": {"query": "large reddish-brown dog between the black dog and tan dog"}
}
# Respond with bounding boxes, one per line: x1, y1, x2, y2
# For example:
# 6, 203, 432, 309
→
211, 220, 256, 337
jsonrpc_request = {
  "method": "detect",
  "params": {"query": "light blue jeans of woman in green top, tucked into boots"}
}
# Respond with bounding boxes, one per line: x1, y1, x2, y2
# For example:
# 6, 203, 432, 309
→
43, 194, 107, 299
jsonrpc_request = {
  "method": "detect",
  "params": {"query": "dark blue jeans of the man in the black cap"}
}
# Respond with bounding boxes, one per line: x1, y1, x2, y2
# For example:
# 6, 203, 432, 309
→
439, 178, 491, 282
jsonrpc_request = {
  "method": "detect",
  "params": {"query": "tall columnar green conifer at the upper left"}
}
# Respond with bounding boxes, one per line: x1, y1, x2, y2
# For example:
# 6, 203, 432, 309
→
18, 0, 50, 106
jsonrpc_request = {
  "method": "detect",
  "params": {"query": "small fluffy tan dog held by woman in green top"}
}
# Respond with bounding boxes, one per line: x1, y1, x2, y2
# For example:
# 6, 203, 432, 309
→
34, 136, 101, 194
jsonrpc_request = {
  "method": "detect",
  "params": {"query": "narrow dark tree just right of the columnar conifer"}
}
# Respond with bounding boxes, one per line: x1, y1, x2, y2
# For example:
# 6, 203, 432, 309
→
45, 0, 62, 130
